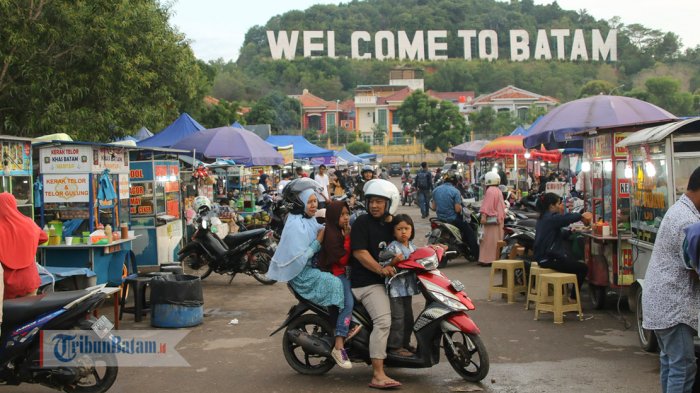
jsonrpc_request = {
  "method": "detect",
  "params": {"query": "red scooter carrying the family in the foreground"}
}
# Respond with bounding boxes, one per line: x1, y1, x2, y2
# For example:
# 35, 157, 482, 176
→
270, 246, 489, 382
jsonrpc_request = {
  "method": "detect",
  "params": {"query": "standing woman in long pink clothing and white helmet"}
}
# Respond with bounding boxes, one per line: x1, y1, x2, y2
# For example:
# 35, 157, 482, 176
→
479, 172, 505, 266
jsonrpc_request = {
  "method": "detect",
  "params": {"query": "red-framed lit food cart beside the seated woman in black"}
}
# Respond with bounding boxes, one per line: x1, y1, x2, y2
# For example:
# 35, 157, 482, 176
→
582, 128, 635, 309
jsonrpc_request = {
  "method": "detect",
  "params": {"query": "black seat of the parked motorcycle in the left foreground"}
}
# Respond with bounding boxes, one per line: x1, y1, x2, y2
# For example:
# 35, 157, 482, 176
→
2, 291, 87, 330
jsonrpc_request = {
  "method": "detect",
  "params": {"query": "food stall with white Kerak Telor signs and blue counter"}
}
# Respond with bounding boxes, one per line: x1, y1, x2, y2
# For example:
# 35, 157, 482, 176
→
34, 141, 133, 284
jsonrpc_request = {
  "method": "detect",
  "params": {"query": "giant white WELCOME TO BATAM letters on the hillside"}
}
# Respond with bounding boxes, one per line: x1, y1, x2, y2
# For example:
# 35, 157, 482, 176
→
267, 29, 617, 61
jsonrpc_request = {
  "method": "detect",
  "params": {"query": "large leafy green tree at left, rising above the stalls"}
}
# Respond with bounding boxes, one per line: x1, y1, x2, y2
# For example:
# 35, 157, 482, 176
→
0, 0, 209, 141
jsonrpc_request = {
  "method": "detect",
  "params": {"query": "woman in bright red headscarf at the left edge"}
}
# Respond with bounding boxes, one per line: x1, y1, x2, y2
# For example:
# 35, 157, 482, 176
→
0, 192, 48, 299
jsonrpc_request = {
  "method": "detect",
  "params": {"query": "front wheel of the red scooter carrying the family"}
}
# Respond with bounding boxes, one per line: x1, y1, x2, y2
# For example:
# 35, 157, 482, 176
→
442, 332, 489, 382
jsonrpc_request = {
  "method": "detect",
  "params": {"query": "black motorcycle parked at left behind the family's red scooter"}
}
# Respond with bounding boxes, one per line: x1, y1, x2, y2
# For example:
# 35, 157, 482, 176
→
178, 212, 277, 285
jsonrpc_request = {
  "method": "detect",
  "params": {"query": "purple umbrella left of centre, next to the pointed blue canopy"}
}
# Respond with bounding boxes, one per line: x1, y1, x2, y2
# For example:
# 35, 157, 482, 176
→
172, 127, 284, 166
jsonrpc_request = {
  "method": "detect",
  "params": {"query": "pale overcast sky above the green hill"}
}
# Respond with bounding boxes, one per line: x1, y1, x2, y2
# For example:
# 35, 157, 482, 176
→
172, 0, 700, 60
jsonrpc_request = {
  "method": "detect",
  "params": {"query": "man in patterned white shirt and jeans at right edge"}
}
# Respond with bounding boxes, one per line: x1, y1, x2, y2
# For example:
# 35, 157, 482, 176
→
641, 167, 700, 393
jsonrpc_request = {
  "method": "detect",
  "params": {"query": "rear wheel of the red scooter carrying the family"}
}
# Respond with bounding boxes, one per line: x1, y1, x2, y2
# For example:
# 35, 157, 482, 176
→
282, 314, 335, 375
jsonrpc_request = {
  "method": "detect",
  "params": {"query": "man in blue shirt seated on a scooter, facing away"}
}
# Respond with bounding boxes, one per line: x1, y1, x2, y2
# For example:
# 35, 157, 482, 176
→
433, 173, 479, 260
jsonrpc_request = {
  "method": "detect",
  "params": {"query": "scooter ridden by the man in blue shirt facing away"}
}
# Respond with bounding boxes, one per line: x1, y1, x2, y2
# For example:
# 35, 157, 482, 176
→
425, 200, 481, 267
